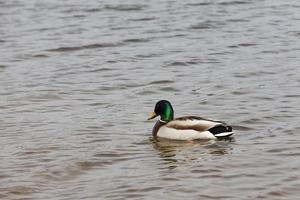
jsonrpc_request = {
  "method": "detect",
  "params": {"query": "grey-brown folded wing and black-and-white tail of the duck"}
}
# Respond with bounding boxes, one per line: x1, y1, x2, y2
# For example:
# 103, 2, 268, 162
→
166, 116, 233, 137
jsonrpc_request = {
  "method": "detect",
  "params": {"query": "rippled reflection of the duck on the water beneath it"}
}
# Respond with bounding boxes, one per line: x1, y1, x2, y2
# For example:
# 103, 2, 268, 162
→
150, 138, 234, 169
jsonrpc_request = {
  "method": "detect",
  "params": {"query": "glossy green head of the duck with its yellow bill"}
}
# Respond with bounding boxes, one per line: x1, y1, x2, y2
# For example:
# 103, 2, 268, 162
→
148, 100, 174, 122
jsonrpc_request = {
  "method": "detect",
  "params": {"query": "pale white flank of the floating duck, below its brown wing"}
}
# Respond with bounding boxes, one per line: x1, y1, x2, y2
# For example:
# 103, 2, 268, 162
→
157, 126, 216, 140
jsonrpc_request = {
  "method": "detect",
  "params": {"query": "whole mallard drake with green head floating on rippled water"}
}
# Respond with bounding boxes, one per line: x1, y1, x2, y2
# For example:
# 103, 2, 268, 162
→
148, 100, 233, 140
